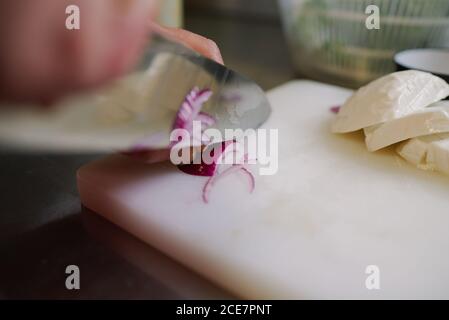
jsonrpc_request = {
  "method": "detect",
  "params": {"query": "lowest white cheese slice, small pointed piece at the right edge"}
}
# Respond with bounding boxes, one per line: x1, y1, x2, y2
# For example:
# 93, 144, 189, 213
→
396, 133, 449, 174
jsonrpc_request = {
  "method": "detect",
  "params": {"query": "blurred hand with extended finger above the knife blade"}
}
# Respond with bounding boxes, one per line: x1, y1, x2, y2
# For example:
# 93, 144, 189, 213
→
0, 0, 223, 103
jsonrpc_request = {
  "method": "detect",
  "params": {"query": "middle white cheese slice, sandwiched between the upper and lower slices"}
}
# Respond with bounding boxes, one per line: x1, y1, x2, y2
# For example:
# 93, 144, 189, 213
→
365, 101, 449, 151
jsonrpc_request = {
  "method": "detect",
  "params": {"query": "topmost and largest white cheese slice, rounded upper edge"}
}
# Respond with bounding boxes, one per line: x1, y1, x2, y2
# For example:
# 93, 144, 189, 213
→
332, 70, 449, 133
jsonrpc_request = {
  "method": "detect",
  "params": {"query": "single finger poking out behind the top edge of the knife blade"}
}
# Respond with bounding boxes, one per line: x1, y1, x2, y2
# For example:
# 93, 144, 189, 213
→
150, 22, 224, 64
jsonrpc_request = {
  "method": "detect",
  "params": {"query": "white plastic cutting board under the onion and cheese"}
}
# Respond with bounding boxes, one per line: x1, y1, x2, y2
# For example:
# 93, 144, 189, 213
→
78, 81, 449, 298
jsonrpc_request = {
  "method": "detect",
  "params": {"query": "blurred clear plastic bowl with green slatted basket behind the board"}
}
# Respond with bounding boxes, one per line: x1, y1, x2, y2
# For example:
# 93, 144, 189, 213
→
279, 0, 449, 87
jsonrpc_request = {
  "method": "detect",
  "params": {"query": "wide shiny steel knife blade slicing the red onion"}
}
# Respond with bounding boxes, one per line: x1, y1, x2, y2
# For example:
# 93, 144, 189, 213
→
0, 35, 270, 153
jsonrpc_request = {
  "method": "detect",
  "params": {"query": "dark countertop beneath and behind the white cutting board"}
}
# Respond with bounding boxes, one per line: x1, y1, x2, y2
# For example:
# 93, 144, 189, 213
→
0, 14, 294, 299
